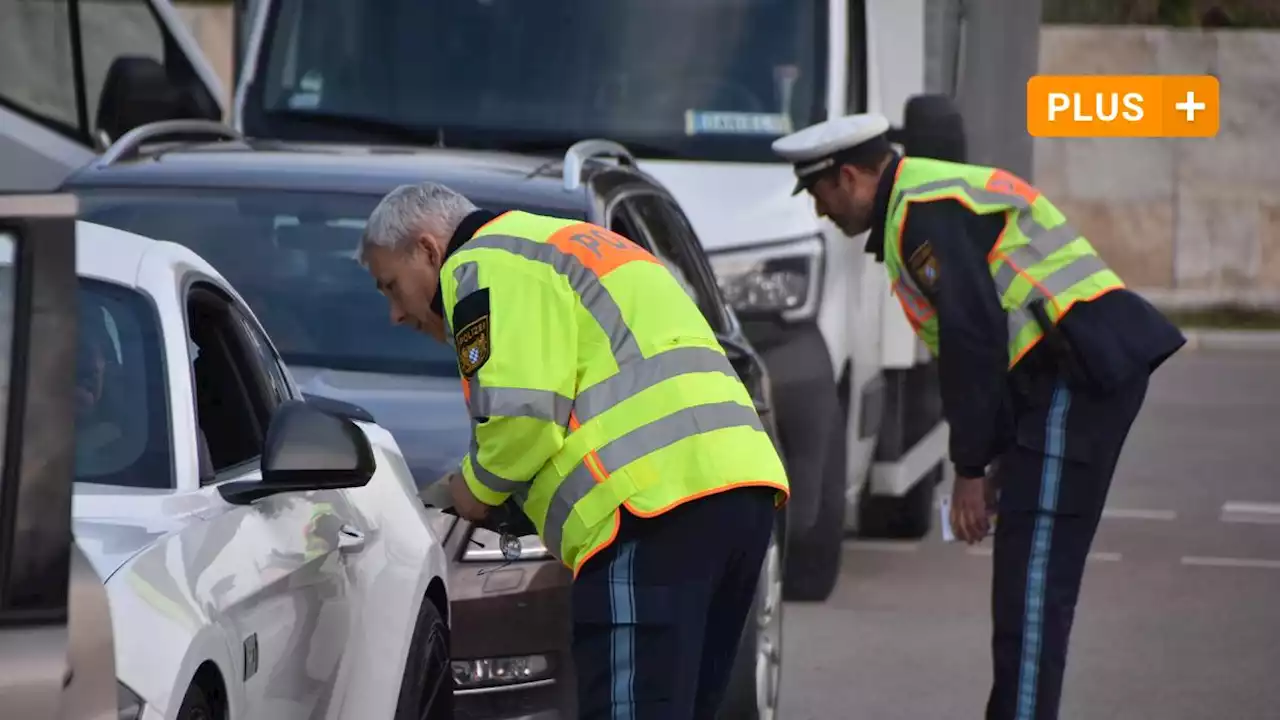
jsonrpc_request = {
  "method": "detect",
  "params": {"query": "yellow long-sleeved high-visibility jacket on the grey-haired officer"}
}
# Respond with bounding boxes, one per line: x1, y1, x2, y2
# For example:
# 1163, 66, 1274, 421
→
440, 211, 788, 577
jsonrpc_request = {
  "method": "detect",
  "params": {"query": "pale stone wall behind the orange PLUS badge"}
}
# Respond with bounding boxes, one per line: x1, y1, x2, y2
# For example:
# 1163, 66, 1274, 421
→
1034, 26, 1280, 307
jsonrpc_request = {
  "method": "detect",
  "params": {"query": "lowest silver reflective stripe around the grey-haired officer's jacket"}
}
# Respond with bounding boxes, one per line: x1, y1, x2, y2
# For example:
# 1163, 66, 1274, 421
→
535, 401, 764, 556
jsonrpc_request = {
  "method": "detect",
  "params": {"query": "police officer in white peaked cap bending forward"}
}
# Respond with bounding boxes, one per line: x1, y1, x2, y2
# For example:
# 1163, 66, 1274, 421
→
773, 115, 1185, 720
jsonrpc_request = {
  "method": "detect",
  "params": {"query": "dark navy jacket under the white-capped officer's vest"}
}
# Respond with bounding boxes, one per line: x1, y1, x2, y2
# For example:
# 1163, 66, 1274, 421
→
867, 156, 1187, 478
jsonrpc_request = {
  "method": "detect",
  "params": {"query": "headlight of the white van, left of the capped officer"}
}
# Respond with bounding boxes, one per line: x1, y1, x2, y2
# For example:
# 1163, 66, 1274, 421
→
708, 236, 824, 322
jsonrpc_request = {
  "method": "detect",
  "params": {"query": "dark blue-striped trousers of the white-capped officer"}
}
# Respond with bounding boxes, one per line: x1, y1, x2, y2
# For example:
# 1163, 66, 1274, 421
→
987, 366, 1148, 720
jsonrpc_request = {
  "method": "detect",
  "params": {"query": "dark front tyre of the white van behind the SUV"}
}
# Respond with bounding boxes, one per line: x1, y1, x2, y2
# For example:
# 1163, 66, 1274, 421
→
782, 404, 849, 602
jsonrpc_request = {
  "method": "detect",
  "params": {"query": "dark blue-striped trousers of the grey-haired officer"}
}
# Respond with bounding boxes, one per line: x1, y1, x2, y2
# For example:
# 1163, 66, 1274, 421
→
573, 487, 776, 720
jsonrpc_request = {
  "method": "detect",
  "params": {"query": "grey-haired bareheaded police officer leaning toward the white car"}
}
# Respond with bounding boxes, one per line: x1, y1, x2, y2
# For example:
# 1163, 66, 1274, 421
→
360, 183, 788, 720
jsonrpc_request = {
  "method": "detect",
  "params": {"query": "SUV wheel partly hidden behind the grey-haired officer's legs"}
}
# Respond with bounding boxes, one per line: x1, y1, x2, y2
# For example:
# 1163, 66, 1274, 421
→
718, 525, 782, 720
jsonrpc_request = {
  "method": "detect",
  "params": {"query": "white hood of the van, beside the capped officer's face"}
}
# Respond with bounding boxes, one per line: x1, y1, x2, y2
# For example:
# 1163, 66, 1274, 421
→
639, 160, 822, 252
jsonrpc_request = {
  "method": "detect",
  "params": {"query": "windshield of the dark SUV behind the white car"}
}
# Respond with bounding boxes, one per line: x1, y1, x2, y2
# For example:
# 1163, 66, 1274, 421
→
77, 188, 563, 377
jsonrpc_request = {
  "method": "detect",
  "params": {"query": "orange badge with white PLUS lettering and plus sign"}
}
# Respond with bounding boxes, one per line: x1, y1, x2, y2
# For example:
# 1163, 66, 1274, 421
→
1027, 76, 1220, 137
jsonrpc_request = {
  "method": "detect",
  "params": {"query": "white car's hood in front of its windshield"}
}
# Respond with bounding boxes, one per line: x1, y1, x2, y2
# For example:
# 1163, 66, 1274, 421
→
72, 483, 209, 583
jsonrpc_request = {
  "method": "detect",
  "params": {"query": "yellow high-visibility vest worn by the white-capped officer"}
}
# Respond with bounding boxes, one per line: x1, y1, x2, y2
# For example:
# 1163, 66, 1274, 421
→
884, 158, 1124, 368
